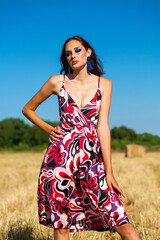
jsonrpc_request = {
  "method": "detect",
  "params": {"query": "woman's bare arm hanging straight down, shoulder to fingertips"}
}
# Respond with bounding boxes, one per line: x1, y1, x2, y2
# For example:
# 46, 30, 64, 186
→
97, 78, 125, 197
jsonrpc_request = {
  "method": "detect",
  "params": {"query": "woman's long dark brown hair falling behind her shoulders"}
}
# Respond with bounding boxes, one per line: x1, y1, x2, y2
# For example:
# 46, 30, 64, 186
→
60, 35, 105, 77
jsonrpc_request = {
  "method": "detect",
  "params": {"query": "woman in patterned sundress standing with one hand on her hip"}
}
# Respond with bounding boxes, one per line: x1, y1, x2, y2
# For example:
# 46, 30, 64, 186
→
23, 36, 140, 240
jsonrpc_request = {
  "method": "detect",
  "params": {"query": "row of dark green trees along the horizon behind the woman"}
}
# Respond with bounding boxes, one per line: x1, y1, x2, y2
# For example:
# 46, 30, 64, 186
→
0, 118, 160, 151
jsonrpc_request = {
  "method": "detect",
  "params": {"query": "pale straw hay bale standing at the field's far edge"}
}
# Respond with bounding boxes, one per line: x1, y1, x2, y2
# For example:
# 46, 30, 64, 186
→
125, 144, 146, 158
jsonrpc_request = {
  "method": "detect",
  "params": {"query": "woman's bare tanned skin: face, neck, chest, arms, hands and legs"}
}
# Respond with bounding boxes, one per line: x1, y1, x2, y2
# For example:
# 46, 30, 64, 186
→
22, 40, 140, 240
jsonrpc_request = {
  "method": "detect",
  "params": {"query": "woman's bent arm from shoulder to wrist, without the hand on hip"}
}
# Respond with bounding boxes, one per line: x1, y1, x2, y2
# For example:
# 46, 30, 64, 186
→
22, 75, 62, 134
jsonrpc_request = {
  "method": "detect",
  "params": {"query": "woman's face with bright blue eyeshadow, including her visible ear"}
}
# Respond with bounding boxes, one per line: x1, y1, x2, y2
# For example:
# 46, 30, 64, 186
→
65, 40, 91, 70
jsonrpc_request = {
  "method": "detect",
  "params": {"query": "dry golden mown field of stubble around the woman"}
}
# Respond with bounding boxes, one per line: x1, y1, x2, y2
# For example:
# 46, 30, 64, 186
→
0, 152, 160, 240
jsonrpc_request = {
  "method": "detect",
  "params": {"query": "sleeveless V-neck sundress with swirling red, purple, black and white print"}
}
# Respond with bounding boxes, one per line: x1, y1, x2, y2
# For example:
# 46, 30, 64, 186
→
37, 75, 130, 232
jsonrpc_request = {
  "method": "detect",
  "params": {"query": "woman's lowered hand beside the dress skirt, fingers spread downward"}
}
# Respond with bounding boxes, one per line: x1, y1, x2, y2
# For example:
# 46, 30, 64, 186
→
106, 173, 126, 198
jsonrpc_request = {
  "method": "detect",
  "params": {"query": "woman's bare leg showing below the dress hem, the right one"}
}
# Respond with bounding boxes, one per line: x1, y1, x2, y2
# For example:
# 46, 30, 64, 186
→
113, 223, 141, 240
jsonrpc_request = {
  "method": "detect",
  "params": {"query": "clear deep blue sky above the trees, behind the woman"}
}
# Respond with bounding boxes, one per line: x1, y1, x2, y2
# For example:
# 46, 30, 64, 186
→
0, 0, 160, 136
